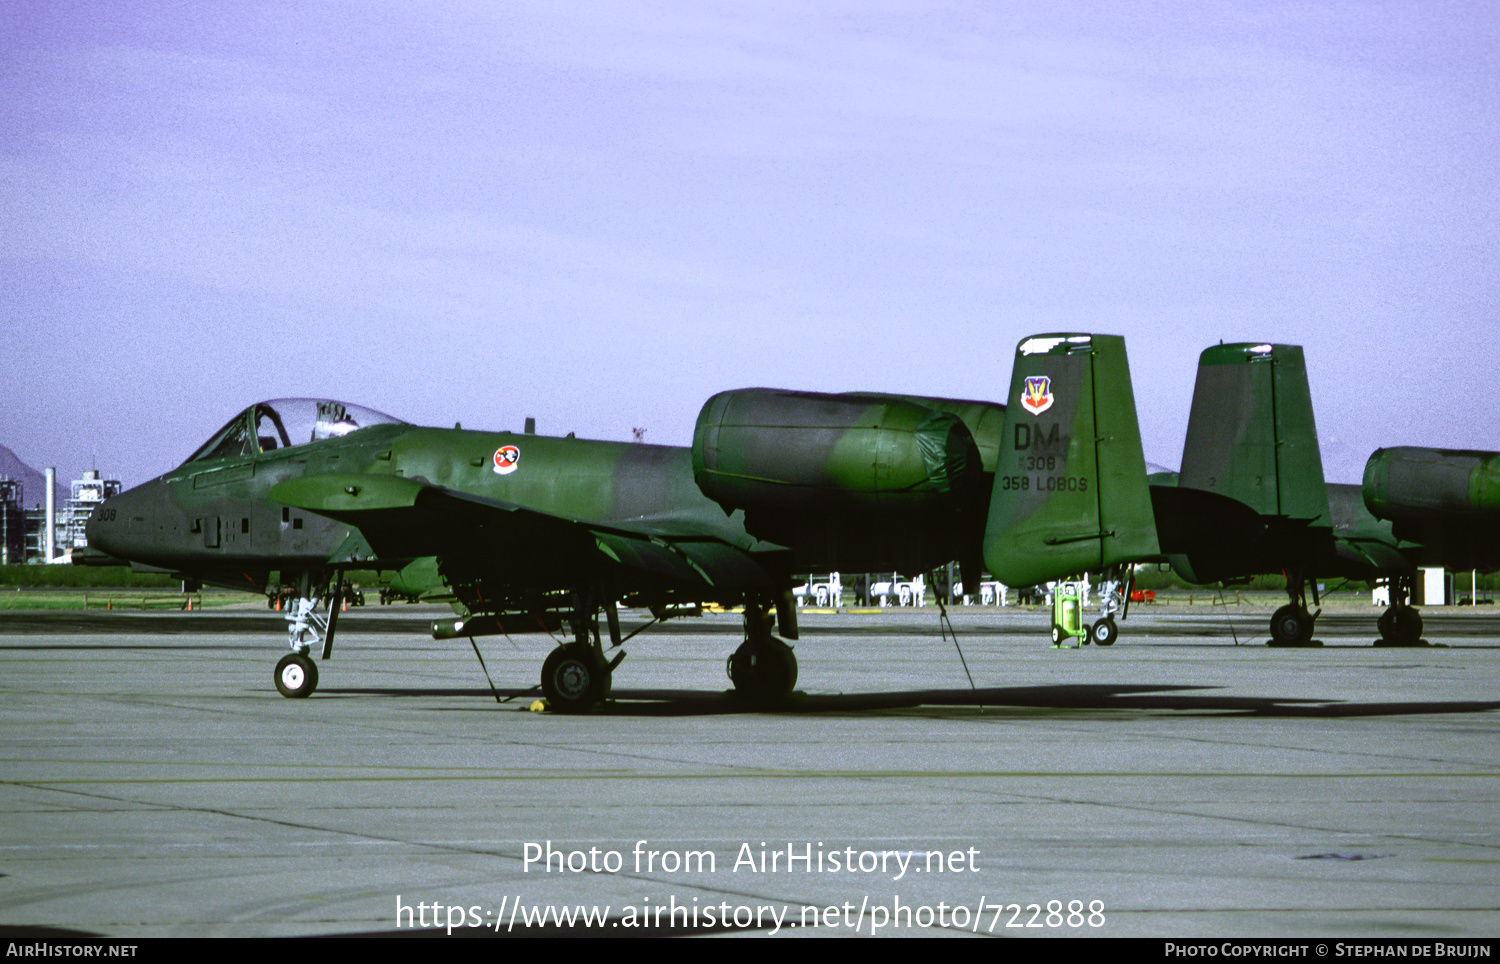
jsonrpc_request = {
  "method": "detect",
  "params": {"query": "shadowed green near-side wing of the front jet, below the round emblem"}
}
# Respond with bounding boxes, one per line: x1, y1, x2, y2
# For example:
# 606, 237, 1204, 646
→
270, 472, 776, 591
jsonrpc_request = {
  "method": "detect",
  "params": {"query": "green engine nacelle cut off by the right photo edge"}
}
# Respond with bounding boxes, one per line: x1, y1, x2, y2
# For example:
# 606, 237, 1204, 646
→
1364, 447, 1500, 522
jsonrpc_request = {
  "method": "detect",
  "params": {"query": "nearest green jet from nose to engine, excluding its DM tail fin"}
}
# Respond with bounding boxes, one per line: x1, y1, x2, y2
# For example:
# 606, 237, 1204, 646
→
89, 388, 1020, 711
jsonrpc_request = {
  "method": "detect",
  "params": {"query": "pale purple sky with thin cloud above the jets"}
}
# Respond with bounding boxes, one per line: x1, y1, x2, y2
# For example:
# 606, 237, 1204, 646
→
0, 0, 1500, 484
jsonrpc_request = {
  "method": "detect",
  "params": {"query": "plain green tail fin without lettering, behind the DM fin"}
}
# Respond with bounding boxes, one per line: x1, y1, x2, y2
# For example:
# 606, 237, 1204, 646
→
1178, 343, 1332, 526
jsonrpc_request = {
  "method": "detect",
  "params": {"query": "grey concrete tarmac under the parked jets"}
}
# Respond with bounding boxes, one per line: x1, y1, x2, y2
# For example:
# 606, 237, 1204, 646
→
0, 607, 1500, 942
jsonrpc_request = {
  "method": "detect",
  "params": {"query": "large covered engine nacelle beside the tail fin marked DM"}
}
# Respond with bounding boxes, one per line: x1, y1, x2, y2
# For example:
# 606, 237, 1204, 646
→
693, 388, 983, 516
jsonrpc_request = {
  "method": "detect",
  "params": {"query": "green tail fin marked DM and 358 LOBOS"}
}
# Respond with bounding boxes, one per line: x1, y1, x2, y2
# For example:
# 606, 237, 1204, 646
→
984, 334, 1160, 586
